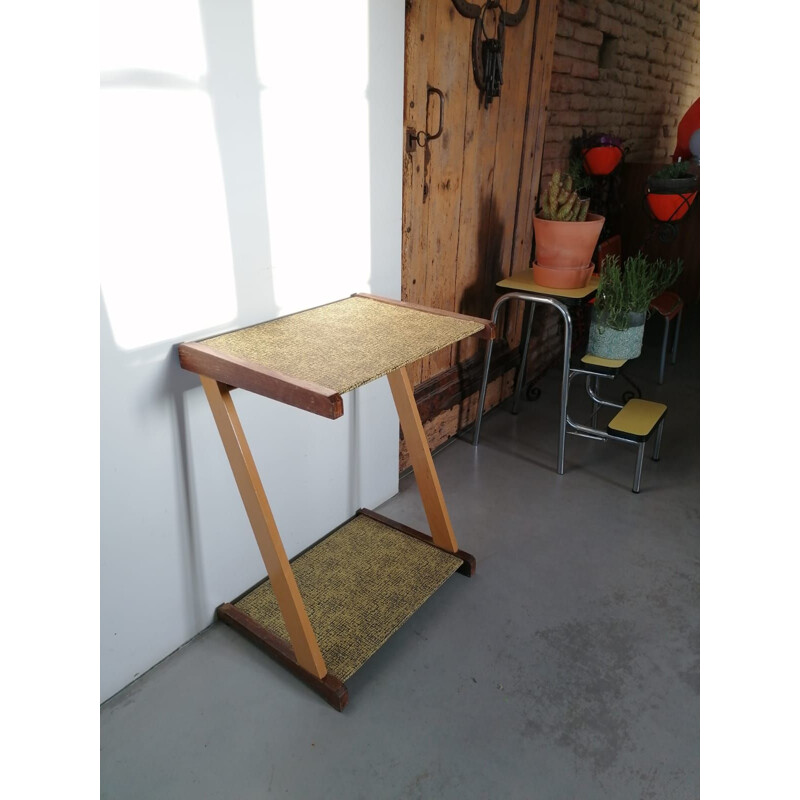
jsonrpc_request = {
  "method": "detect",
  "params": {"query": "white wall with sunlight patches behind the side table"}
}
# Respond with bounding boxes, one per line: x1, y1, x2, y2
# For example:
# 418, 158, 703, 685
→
100, 0, 404, 699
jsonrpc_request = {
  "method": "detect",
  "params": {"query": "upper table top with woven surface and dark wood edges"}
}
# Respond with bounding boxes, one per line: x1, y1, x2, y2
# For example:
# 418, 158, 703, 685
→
178, 294, 494, 418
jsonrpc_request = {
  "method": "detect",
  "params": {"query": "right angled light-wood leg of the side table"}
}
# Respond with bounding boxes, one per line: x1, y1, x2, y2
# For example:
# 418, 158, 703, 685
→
386, 367, 458, 553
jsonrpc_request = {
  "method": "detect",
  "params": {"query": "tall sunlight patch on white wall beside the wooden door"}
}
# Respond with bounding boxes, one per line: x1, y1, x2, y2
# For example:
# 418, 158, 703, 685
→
253, 0, 371, 314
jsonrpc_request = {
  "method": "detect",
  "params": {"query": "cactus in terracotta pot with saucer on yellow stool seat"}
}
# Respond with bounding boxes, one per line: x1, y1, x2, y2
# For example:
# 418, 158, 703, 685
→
533, 169, 605, 289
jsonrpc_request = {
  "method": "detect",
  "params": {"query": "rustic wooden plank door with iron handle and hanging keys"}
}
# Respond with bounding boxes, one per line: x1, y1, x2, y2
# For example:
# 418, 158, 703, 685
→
402, 0, 557, 456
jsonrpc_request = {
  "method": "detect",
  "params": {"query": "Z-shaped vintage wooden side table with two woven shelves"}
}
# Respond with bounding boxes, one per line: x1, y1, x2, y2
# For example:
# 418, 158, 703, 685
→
178, 294, 495, 711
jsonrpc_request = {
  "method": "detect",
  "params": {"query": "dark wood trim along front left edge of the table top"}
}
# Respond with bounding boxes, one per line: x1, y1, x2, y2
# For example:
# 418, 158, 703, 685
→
178, 342, 344, 419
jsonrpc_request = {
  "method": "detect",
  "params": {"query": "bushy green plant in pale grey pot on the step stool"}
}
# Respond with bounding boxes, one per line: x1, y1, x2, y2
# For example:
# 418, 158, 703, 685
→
587, 253, 683, 359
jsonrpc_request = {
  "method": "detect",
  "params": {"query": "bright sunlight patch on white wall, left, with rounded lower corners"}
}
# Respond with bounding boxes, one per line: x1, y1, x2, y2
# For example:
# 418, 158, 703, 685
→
100, 88, 237, 349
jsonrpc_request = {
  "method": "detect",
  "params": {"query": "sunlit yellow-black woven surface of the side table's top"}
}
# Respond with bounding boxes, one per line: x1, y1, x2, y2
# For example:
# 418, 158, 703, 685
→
201, 297, 484, 394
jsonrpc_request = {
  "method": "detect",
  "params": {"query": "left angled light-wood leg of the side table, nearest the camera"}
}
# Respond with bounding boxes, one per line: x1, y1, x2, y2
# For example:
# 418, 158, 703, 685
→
200, 375, 327, 678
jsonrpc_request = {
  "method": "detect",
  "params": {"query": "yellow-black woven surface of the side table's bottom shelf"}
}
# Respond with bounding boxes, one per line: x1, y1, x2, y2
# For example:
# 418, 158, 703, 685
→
235, 515, 463, 681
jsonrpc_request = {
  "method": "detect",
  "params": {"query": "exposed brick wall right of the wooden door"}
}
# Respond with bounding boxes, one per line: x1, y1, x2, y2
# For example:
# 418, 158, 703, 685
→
542, 0, 700, 186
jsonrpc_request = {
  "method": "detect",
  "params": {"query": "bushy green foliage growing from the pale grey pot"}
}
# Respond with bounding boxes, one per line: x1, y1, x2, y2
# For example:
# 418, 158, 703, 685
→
594, 253, 683, 331
